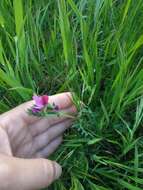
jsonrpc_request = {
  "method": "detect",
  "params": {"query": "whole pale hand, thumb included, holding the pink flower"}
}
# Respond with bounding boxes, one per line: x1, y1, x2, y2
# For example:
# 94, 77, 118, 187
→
0, 93, 76, 190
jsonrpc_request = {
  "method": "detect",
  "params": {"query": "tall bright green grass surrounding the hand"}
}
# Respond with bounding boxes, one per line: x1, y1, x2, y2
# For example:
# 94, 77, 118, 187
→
0, 0, 143, 190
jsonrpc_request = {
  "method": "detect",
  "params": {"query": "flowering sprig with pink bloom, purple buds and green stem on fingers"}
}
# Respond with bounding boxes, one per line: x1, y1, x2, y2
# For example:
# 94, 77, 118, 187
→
28, 95, 73, 118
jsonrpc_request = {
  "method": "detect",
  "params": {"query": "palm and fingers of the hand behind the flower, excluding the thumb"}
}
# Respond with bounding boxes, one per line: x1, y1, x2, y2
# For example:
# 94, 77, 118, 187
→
0, 94, 76, 158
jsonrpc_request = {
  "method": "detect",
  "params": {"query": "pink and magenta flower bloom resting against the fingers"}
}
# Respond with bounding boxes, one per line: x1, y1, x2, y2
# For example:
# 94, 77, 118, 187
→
32, 95, 49, 113
